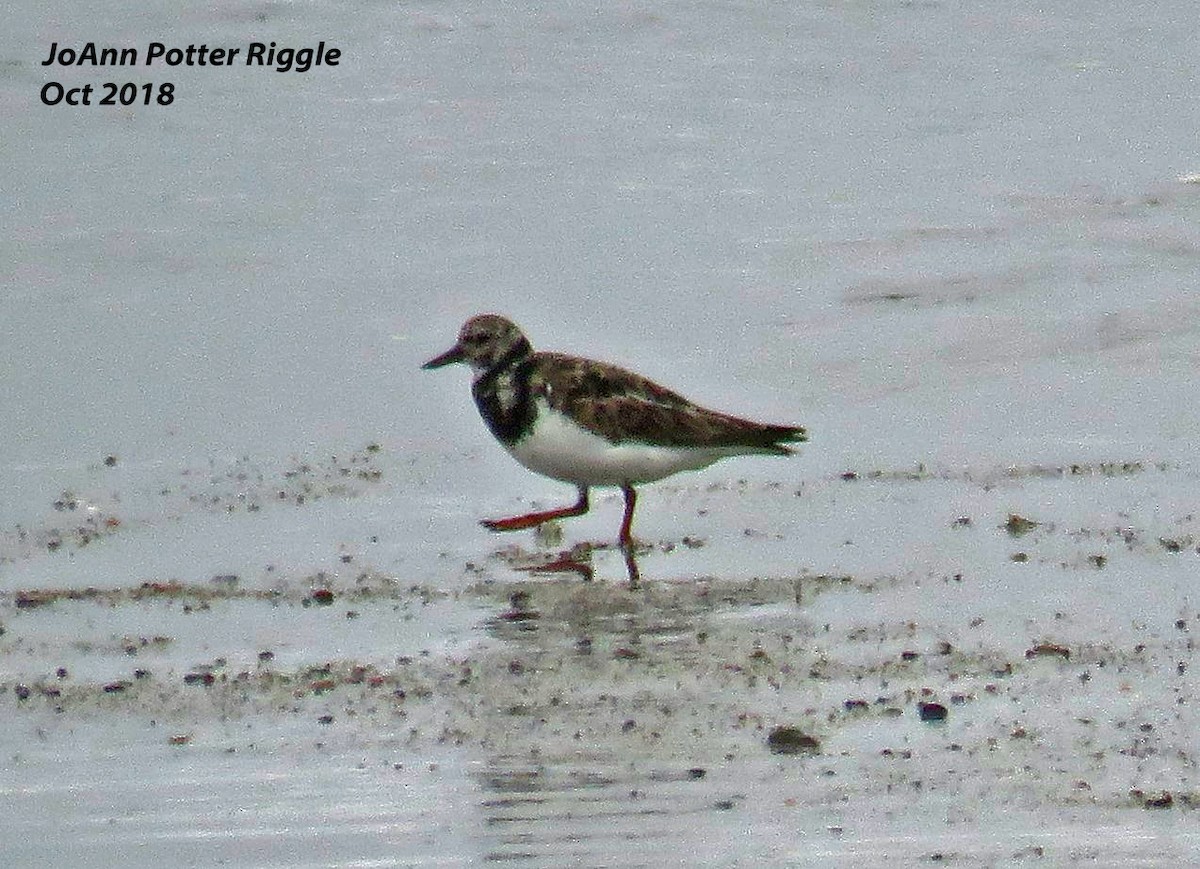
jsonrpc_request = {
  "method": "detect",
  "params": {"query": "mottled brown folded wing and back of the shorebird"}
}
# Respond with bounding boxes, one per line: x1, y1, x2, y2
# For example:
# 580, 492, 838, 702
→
530, 353, 805, 455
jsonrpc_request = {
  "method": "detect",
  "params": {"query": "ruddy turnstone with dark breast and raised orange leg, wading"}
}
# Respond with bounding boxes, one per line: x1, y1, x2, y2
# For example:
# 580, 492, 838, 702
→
421, 313, 808, 549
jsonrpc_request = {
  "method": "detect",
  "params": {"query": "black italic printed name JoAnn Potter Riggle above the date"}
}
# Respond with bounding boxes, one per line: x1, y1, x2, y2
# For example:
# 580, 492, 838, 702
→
42, 41, 342, 72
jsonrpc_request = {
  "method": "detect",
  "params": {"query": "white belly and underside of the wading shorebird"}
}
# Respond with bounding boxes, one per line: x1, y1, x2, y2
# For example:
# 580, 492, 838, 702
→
508, 398, 724, 486
